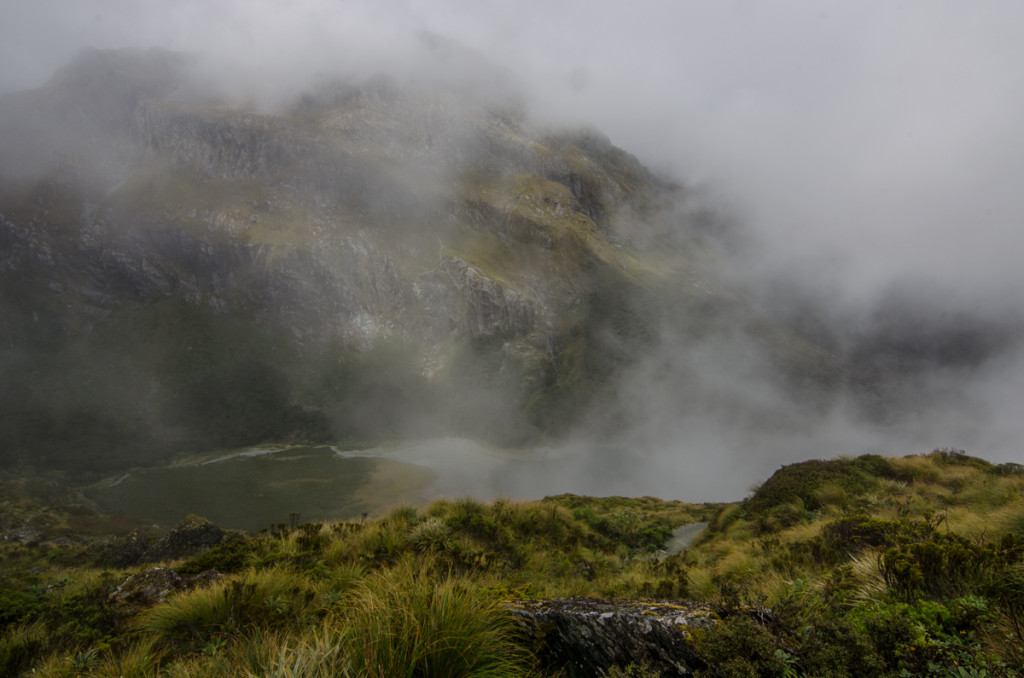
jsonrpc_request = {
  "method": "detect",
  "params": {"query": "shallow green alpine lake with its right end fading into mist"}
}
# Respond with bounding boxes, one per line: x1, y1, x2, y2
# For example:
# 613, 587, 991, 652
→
84, 438, 700, 532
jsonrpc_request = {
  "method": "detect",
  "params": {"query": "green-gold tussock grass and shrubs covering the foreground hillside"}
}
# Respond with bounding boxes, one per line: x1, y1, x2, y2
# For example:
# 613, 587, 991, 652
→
0, 451, 1024, 677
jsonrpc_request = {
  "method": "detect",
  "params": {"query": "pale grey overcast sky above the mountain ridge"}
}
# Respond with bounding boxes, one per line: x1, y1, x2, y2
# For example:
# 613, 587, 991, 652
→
0, 0, 1024, 305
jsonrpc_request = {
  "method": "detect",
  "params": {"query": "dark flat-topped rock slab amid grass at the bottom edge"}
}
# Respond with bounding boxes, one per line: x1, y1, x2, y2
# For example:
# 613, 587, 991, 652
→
510, 598, 715, 676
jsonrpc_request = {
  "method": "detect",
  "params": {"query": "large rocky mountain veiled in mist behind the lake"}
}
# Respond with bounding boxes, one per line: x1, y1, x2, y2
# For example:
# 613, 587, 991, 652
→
8, 47, 1003, 469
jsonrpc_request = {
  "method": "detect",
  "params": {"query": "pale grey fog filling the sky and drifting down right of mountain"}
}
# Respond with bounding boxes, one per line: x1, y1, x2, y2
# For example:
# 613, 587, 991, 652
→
0, 0, 1024, 500
